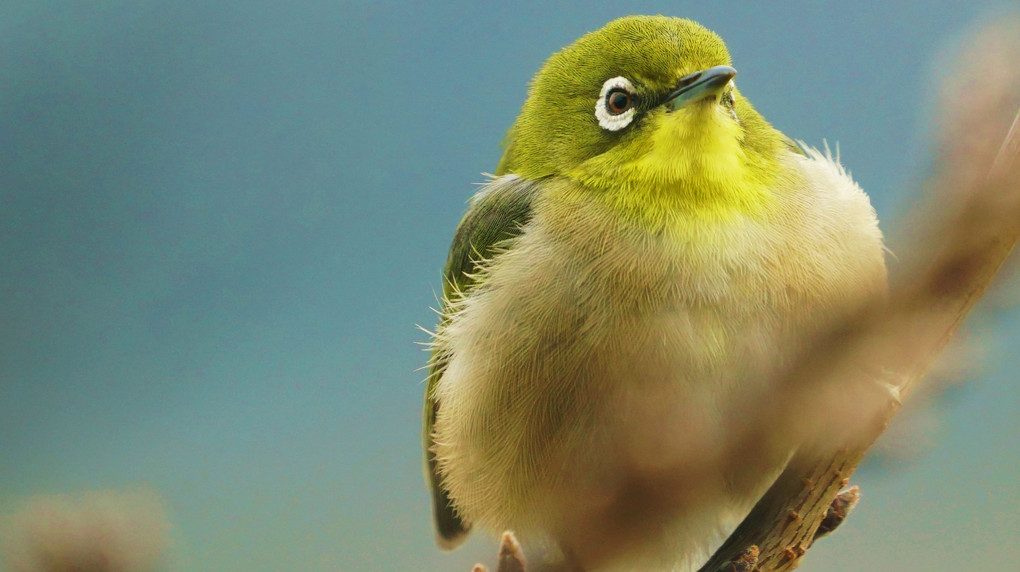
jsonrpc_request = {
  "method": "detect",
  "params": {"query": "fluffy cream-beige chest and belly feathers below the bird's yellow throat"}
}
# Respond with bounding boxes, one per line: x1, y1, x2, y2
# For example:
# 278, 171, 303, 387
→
435, 152, 884, 566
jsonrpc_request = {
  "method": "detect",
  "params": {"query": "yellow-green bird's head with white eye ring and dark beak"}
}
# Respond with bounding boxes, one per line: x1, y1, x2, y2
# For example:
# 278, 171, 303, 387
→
497, 16, 788, 227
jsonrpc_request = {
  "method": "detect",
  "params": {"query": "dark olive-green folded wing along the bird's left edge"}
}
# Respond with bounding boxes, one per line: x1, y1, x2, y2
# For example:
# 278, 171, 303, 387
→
422, 175, 538, 550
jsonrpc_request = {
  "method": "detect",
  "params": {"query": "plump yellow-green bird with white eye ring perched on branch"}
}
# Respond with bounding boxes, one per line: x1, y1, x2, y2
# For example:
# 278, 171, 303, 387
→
424, 16, 886, 571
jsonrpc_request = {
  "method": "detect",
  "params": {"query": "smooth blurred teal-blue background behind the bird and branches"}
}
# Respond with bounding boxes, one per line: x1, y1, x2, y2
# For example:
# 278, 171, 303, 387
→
0, 0, 1020, 572
